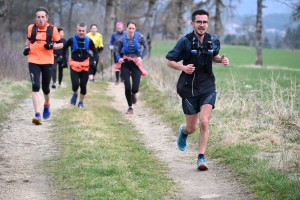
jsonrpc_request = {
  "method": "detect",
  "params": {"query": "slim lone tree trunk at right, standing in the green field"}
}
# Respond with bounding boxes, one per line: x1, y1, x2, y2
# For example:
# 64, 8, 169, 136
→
255, 0, 263, 66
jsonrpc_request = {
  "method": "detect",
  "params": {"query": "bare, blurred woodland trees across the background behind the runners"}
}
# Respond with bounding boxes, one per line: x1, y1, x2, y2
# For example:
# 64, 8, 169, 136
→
0, 0, 300, 69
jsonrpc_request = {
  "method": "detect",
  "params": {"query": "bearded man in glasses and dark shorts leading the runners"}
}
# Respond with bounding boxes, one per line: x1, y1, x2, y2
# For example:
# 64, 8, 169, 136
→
166, 10, 229, 170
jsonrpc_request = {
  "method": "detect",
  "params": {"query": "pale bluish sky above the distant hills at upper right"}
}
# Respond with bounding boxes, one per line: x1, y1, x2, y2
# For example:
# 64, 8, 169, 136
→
236, 0, 297, 15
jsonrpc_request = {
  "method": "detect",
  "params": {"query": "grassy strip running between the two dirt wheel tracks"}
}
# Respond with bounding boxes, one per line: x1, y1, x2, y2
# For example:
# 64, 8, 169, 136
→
47, 81, 173, 199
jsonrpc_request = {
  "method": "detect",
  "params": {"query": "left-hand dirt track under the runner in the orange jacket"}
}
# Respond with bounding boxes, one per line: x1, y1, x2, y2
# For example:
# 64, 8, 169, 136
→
0, 89, 66, 200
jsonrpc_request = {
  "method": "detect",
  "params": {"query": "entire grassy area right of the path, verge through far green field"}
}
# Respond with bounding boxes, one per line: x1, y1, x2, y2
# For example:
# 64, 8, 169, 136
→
141, 41, 300, 200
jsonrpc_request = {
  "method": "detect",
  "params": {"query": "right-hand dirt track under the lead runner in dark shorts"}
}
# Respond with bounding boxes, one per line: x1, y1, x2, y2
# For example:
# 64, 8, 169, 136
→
107, 83, 253, 200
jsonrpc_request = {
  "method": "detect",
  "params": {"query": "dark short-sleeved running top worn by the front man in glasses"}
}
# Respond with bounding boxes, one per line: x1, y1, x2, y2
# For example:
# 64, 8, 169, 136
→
166, 33, 219, 98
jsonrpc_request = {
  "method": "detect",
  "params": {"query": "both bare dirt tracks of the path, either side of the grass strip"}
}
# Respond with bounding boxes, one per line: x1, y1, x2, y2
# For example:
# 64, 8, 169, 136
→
0, 80, 253, 200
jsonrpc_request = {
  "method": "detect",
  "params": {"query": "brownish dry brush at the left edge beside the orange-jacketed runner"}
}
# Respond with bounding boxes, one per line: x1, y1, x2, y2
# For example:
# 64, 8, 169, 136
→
0, 38, 29, 81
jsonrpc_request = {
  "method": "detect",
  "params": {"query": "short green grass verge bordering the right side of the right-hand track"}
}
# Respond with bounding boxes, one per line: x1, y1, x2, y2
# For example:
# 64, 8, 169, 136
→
141, 79, 300, 200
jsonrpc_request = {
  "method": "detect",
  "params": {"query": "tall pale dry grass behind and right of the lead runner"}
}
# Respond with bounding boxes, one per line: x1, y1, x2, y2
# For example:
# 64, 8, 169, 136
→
145, 58, 300, 179
